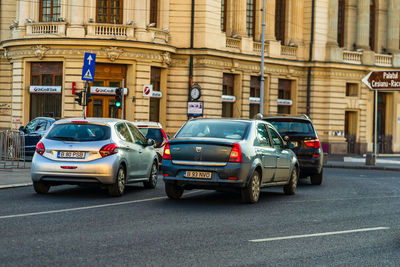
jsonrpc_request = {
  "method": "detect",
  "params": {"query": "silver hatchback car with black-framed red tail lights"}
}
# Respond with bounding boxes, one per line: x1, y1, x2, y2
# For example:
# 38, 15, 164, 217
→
31, 118, 158, 196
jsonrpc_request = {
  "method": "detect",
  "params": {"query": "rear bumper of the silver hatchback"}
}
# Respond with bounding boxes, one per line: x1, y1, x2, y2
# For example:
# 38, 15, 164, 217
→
31, 154, 119, 184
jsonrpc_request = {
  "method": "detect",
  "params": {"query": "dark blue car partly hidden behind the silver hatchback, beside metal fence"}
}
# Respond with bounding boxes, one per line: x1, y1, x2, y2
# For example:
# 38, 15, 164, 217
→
19, 117, 56, 156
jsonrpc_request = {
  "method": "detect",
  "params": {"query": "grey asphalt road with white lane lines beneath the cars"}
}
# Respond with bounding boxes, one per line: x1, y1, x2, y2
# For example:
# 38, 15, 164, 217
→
0, 169, 400, 266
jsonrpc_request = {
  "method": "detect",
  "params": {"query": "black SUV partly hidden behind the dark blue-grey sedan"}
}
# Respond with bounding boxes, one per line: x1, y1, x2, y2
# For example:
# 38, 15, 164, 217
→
262, 115, 324, 185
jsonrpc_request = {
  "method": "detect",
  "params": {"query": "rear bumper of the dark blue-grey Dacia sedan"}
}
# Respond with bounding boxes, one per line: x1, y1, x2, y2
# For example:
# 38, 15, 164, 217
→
162, 160, 250, 189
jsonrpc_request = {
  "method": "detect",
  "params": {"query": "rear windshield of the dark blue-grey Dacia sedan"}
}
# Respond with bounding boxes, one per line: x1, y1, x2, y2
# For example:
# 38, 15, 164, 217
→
176, 120, 250, 140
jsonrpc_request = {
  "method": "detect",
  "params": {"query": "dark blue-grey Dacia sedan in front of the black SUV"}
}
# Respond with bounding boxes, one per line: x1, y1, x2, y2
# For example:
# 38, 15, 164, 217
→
162, 119, 299, 203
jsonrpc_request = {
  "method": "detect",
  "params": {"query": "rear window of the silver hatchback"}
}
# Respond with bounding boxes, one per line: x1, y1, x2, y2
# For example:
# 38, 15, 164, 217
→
46, 123, 111, 142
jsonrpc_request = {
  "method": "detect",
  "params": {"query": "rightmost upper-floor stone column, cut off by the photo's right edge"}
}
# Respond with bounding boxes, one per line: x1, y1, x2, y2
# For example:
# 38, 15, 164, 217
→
386, 0, 400, 54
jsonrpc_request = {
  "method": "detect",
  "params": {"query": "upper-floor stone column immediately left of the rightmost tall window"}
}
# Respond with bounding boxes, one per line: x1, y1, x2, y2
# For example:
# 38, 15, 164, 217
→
356, 0, 370, 50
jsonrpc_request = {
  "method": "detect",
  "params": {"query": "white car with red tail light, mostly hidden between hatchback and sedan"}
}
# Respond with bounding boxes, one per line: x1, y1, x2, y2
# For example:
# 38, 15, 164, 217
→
133, 122, 169, 163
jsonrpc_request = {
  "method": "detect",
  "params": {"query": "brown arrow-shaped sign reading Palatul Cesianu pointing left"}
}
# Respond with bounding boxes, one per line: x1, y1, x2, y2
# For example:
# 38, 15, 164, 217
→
362, 71, 400, 91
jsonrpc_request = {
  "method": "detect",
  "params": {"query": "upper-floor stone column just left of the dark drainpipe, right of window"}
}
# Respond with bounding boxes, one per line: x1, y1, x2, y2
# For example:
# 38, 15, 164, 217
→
289, 0, 304, 45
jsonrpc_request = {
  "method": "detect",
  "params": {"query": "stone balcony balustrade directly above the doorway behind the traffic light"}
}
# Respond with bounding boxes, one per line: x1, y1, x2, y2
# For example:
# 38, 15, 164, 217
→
86, 23, 135, 40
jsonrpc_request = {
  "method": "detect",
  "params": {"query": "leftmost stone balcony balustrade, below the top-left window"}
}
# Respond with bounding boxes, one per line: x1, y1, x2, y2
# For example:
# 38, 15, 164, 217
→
26, 22, 67, 38
